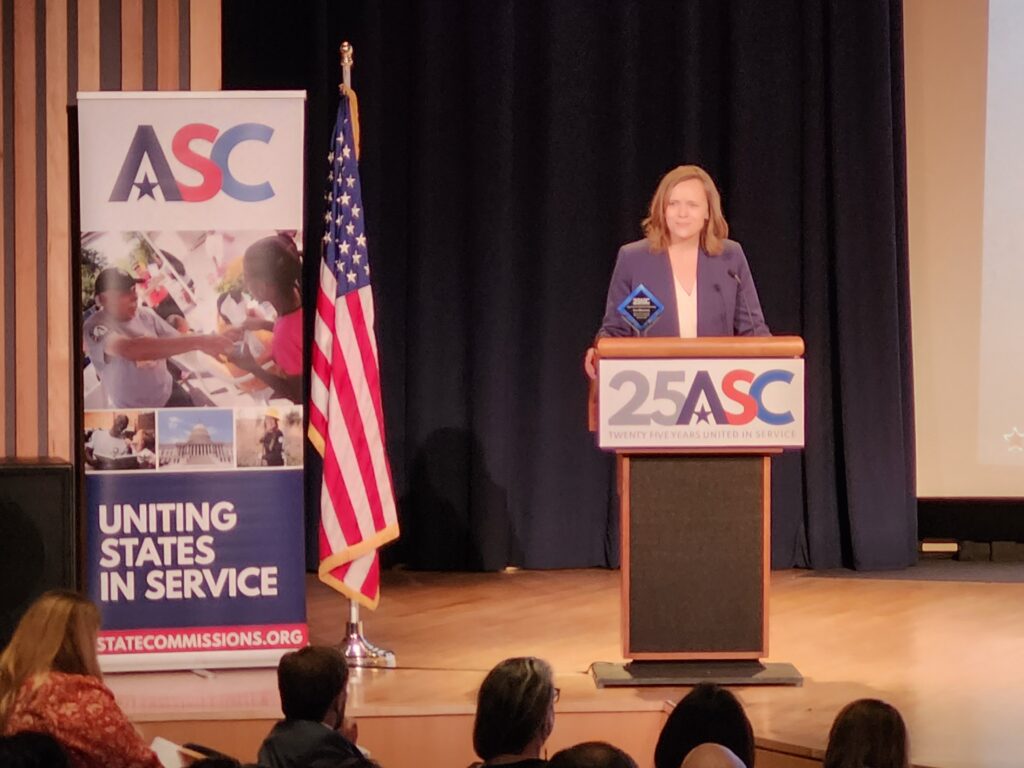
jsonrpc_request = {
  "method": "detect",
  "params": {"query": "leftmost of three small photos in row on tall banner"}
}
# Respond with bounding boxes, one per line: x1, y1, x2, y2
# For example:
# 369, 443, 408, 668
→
84, 411, 157, 472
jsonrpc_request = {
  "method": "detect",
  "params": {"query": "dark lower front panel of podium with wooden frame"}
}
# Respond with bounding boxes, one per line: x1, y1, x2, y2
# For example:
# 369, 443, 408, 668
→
622, 455, 770, 659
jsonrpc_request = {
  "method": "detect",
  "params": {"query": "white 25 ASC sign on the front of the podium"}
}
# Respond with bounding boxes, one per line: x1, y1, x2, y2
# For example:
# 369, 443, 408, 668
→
598, 358, 804, 450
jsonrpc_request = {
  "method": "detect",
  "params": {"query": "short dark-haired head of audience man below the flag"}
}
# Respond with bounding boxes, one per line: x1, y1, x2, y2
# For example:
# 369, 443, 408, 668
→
278, 645, 348, 727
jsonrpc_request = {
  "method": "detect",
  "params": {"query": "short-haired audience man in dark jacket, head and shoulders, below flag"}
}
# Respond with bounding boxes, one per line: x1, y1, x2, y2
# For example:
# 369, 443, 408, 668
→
259, 645, 374, 768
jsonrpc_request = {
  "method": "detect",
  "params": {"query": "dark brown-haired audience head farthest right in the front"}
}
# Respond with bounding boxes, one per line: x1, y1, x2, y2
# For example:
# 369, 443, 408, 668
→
822, 698, 910, 768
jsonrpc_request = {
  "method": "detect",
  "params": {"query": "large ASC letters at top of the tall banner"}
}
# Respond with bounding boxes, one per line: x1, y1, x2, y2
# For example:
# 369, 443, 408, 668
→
110, 123, 274, 203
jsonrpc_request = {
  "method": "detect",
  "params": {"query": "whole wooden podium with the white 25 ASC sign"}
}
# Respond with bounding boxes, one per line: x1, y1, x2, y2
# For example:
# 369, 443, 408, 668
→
591, 337, 804, 685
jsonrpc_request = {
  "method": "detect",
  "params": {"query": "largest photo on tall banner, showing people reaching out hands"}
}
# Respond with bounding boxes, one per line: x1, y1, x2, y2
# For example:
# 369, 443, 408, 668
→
81, 230, 302, 410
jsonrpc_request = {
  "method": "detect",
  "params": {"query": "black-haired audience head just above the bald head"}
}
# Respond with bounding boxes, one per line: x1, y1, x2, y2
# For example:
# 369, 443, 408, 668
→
654, 683, 754, 768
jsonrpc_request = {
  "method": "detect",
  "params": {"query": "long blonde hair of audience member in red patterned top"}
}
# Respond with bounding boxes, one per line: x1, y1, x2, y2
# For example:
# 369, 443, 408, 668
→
0, 590, 102, 731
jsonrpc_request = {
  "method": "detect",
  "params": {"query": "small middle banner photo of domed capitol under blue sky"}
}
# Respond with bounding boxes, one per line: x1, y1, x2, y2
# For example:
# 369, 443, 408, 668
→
158, 408, 234, 469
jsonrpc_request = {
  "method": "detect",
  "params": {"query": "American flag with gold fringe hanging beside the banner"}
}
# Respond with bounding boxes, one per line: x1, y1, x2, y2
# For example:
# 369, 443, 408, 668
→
309, 90, 398, 608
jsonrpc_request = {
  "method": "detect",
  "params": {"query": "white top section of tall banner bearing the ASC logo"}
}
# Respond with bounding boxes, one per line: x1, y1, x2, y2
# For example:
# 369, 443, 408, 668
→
78, 91, 304, 231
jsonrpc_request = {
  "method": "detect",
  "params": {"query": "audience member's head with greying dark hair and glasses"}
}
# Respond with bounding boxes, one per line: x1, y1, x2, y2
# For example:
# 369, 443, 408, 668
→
473, 656, 557, 761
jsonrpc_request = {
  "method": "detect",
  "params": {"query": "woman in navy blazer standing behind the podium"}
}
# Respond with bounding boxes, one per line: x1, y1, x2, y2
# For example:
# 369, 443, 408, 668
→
585, 165, 771, 378
